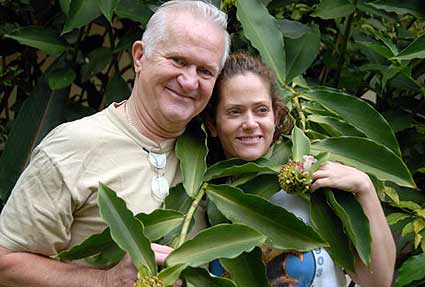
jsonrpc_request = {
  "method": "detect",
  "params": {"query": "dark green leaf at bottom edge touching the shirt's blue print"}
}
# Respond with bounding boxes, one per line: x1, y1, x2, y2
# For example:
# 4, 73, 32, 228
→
220, 247, 269, 287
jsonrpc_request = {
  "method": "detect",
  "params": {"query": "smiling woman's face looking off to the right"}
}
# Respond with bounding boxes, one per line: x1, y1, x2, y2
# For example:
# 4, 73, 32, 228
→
210, 72, 275, 161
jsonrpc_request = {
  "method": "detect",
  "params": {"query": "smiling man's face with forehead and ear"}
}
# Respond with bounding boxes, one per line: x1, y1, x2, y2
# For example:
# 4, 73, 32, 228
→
135, 14, 224, 129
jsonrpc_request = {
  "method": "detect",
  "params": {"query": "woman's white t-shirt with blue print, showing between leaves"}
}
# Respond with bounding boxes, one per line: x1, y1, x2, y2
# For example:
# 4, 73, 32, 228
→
267, 190, 346, 287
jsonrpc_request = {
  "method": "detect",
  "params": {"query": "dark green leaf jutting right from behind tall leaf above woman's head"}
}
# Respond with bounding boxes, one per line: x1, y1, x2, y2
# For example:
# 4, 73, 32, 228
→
285, 25, 320, 83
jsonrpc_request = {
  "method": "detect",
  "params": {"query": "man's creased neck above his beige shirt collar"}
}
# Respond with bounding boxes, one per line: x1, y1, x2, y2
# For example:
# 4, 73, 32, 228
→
124, 97, 185, 144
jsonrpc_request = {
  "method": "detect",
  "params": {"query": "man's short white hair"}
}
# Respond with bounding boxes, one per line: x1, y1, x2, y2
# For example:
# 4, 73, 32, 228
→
142, 0, 230, 70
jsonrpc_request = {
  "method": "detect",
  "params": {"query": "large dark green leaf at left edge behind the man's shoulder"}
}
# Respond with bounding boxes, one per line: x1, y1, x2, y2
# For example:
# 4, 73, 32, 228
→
0, 64, 69, 202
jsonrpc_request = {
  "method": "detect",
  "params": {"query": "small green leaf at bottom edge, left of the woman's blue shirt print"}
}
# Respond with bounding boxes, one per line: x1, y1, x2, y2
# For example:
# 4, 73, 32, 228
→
183, 267, 236, 287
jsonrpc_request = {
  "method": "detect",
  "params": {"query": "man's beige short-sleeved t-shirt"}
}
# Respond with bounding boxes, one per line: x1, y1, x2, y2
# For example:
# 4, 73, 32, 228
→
0, 104, 181, 256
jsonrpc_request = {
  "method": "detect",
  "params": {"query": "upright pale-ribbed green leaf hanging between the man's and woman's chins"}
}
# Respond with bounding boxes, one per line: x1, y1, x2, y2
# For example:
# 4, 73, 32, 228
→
176, 126, 208, 197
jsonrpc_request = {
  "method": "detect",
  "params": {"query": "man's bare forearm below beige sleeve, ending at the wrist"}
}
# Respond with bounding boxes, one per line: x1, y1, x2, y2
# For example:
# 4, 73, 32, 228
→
0, 247, 105, 287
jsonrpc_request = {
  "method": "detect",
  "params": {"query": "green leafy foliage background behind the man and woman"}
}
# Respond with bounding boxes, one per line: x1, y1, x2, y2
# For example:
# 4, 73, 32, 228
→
0, 0, 425, 286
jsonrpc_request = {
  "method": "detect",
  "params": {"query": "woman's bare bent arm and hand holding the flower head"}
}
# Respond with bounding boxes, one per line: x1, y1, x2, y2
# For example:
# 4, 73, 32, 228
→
311, 162, 396, 287
